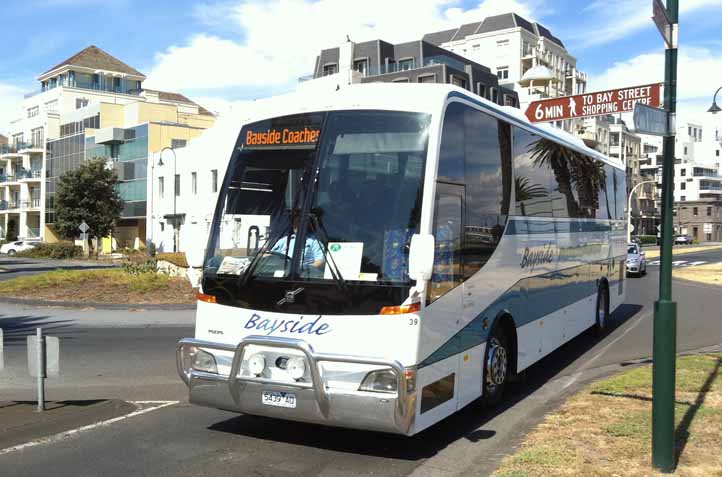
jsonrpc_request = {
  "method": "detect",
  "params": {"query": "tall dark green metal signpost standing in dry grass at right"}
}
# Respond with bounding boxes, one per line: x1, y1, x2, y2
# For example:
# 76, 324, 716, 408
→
652, 0, 679, 472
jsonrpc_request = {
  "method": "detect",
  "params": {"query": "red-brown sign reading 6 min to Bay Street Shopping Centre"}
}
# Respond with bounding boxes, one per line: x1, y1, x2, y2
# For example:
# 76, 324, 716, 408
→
526, 83, 662, 123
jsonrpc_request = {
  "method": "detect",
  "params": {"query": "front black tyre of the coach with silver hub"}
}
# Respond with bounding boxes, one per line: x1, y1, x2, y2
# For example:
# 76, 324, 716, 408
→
481, 325, 512, 406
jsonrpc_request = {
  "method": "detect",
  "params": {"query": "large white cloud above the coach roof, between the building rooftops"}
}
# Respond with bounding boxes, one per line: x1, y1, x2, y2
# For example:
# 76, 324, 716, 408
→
146, 0, 541, 94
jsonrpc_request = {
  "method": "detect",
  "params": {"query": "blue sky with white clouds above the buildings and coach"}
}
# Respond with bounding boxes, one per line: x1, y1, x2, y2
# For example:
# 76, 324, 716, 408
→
0, 0, 722, 130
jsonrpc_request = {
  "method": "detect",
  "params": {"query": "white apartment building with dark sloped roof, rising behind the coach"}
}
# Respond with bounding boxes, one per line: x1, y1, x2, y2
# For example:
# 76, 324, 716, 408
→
424, 13, 587, 110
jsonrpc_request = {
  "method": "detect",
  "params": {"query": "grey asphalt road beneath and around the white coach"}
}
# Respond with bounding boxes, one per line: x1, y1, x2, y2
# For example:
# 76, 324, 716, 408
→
0, 247, 722, 476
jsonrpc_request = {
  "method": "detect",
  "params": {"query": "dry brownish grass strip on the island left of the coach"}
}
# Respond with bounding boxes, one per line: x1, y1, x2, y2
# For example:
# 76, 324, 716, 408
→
0, 269, 195, 304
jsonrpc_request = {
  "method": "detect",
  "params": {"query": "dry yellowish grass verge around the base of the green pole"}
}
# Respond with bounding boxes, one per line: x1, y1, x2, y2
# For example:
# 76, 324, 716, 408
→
493, 354, 722, 477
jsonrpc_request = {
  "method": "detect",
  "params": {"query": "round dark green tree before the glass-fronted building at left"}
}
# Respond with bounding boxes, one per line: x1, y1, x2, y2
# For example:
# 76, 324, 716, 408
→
54, 159, 123, 242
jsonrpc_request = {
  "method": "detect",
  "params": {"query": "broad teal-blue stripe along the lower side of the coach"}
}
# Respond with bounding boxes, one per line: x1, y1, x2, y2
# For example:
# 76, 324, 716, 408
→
418, 256, 625, 368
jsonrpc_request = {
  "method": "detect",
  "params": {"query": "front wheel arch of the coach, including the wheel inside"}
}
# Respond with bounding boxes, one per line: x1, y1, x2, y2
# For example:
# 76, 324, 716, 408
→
481, 311, 517, 406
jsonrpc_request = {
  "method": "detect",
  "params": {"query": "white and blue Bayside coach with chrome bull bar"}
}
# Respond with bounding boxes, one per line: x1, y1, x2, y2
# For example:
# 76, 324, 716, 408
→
178, 84, 626, 435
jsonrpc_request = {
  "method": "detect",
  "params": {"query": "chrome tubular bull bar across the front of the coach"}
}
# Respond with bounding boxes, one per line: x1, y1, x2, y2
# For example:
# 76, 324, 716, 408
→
176, 335, 413, 430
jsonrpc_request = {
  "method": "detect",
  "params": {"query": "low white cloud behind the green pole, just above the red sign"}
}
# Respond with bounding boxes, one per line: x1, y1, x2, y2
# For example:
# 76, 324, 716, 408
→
588, 48, 722, 129
